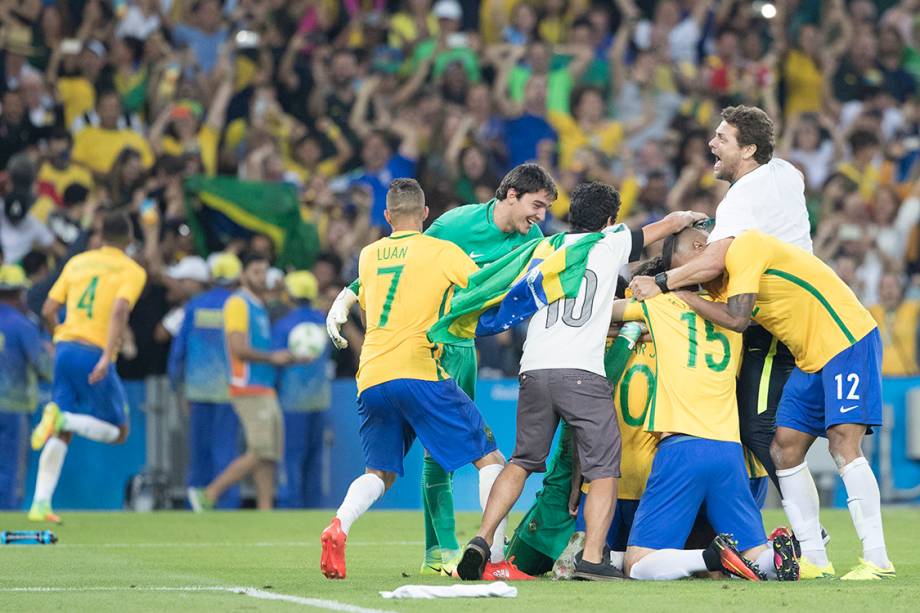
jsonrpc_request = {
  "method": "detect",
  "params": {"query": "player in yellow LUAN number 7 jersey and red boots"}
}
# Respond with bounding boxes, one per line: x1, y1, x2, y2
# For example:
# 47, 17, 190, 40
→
320, 179, 506, 579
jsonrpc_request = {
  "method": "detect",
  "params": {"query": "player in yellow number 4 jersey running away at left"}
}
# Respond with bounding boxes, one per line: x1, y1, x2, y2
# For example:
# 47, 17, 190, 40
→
29, 213, 147, 522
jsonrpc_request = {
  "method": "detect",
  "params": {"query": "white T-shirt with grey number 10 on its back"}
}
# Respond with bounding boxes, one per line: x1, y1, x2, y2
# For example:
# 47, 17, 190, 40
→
521, 224, 643, 376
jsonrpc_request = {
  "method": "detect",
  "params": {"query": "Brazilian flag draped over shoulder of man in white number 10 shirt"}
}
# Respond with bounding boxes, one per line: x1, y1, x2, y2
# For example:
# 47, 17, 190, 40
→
428, 230, 626, 344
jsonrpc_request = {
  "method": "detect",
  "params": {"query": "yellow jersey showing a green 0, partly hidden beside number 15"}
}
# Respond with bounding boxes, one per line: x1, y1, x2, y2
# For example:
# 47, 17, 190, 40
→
613, 343, 658, 500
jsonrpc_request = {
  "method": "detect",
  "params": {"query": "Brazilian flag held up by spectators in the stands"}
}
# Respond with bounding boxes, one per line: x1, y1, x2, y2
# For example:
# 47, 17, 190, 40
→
184, 175, 319, 270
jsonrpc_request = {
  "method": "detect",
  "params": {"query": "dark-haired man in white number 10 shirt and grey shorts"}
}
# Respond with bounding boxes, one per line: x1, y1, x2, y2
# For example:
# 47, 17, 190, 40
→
457, 182, 702, 580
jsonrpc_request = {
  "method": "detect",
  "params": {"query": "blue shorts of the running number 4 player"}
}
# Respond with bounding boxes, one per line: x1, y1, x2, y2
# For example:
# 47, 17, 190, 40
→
51, 341, 128, 426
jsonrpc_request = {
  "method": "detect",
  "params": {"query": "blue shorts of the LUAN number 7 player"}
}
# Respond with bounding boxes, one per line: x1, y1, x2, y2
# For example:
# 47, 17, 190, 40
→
358, 379, 497, 477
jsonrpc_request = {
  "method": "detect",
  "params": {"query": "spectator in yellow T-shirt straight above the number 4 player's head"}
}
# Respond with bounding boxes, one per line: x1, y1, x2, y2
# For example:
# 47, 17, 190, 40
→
73, 91, 153, 175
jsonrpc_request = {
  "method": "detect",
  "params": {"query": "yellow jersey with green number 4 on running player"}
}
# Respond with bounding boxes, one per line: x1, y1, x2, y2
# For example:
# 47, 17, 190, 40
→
48, 247, 147, 349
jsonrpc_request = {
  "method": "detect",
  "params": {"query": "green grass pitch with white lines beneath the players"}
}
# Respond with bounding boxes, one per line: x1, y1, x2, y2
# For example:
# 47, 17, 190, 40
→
0, 508, 920, 613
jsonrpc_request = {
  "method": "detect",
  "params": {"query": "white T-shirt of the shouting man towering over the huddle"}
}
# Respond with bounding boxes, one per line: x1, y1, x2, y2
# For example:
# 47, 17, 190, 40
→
709, 157, 812, 253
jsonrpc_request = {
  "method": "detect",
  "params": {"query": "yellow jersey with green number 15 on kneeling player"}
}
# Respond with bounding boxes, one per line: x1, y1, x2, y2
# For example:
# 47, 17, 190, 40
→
624, 294, 741, 443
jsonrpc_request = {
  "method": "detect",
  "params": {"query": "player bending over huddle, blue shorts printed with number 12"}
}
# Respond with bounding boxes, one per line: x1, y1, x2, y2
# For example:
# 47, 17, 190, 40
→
685, 230, 895, 580
